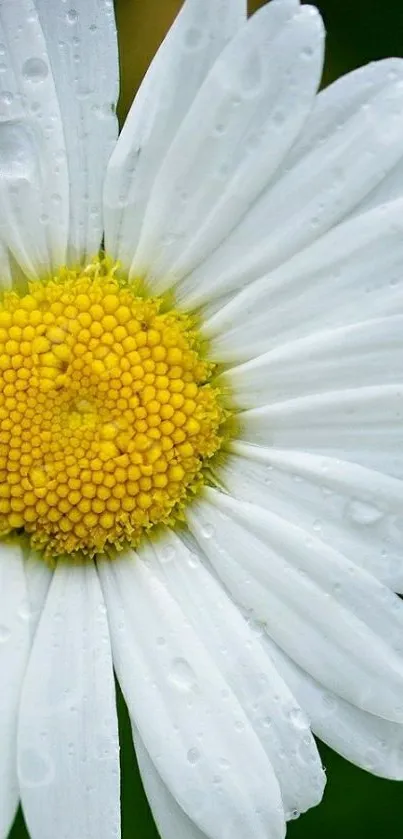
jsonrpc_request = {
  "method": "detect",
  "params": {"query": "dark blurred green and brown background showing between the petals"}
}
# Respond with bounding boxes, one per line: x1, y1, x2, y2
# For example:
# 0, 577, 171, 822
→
10, 0, 403, 839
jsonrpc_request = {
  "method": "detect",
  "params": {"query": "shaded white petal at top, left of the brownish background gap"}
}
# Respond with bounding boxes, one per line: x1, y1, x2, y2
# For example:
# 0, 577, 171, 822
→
35, 0, 119, 262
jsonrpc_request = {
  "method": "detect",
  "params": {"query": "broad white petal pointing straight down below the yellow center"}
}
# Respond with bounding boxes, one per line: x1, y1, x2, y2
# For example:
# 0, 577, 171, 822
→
18, 563, 120, 839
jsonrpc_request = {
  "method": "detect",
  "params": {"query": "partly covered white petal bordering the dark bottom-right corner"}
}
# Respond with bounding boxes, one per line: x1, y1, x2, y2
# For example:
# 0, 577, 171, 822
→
266, 638, 403, 781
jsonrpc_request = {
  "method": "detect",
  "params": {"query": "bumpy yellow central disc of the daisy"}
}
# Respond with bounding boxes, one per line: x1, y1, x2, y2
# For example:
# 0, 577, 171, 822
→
0, 262, 224, 557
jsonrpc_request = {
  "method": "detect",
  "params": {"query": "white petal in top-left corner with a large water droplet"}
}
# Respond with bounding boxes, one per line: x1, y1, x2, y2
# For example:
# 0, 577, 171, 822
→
0, 0, 69, 277
